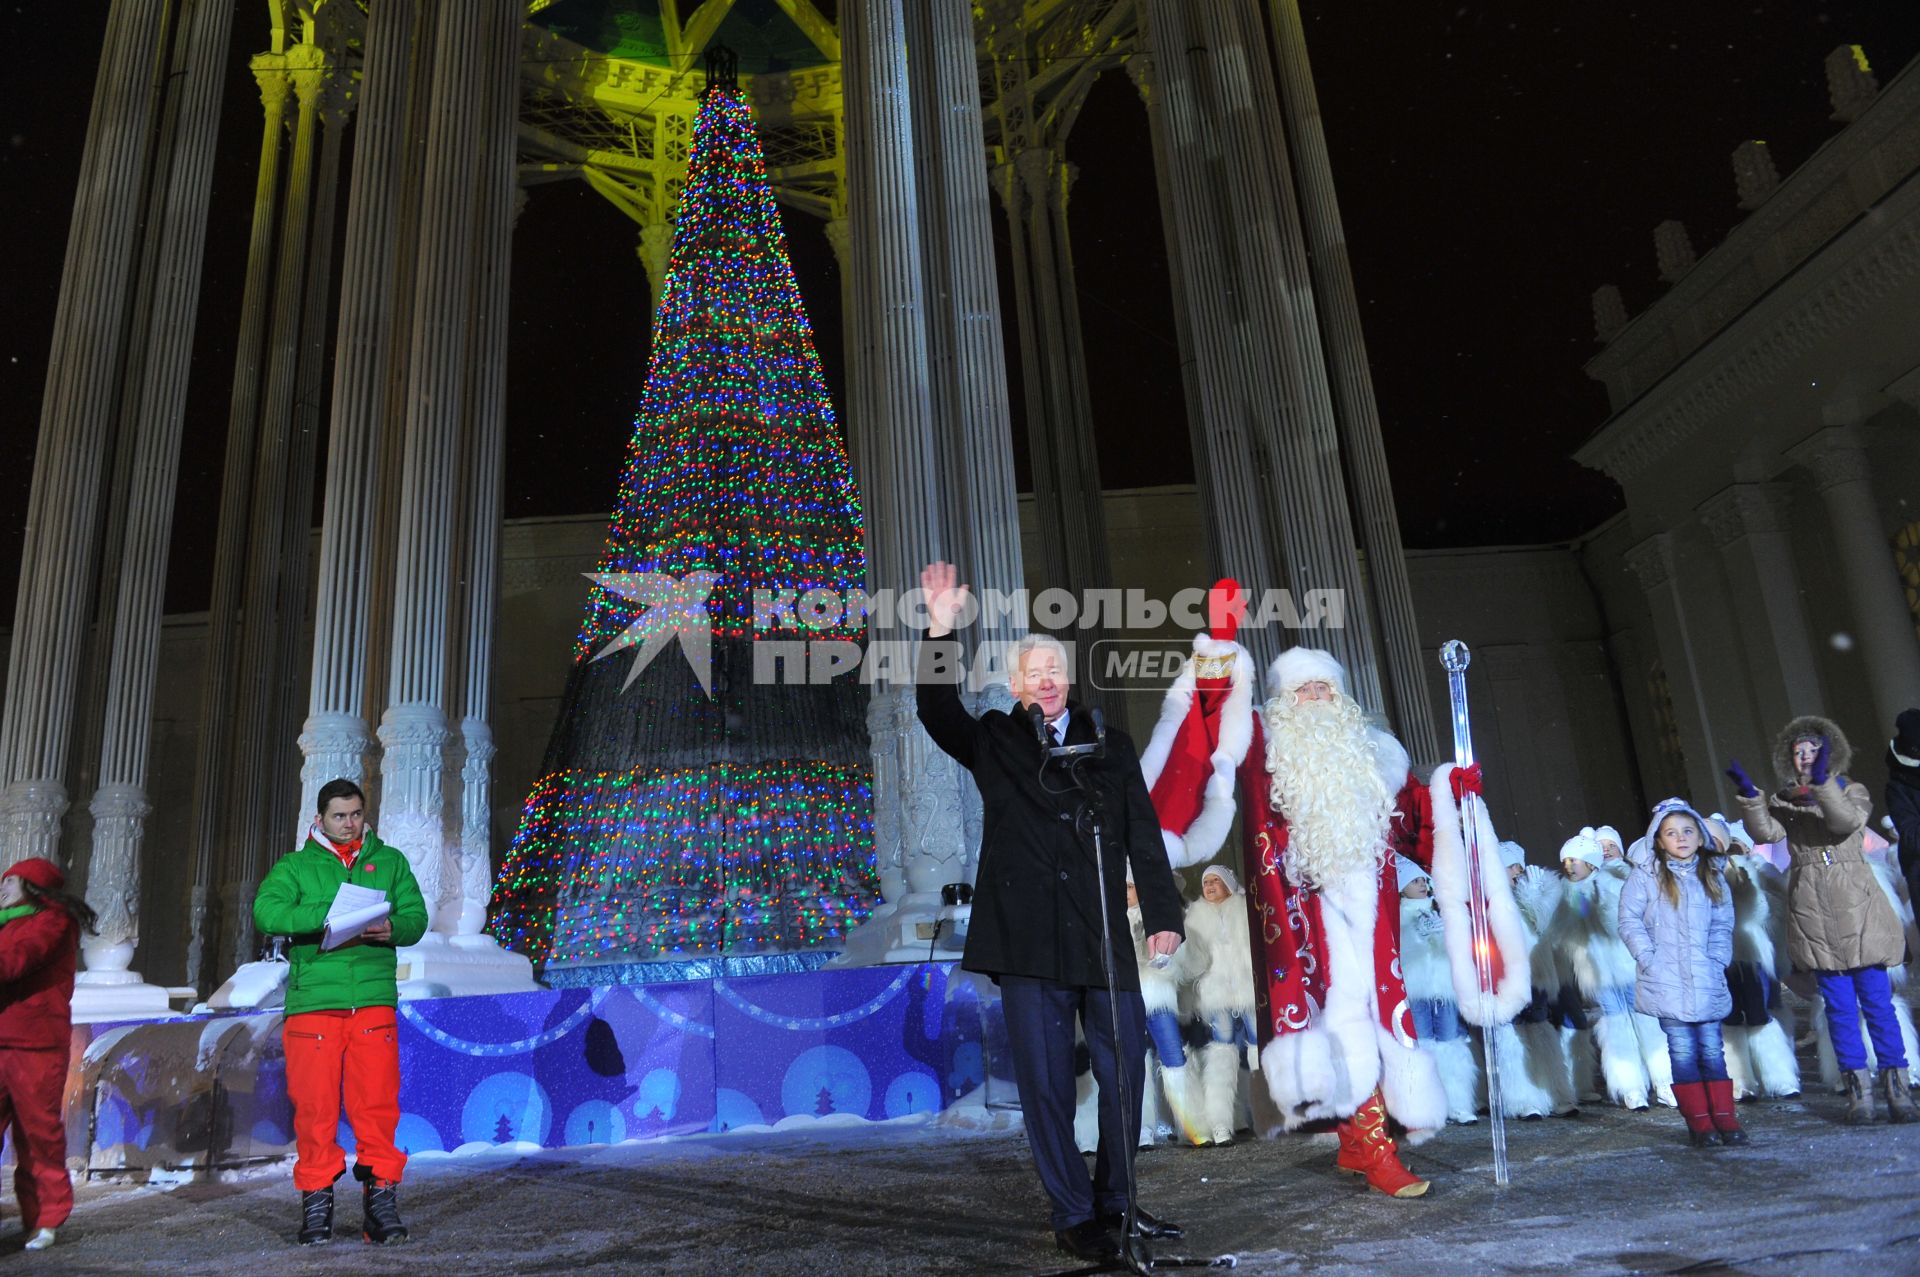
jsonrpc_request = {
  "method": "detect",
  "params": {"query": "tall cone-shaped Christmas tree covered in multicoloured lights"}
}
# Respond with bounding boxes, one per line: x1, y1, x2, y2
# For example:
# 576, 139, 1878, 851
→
492, 79, 879, 970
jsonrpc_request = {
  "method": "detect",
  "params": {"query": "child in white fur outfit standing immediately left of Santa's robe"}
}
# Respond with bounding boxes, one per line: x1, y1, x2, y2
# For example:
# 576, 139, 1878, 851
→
1181, 864, 1258, 1144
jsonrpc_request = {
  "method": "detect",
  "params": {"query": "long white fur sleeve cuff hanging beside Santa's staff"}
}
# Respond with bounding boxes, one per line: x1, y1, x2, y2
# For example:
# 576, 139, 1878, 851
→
1428, 762, 1532, 1027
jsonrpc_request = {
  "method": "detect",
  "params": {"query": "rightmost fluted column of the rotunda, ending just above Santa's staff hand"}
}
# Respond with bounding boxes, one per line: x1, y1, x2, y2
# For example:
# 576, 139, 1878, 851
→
1269, 0, 1442, 762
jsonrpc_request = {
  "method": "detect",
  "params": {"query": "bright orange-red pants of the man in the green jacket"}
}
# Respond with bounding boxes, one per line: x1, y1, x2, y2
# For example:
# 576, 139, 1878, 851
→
280, 1006, 407, 1193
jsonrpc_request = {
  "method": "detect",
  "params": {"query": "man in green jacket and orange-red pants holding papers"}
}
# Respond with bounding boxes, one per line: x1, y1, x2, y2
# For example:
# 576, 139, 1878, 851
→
253, 780, 426, 1246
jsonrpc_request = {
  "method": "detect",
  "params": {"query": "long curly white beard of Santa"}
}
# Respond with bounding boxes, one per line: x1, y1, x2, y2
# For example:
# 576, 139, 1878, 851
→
1265, 697, 1396, 887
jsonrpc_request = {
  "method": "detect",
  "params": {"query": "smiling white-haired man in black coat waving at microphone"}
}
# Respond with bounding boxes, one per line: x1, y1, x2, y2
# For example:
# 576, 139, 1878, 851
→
916, 563, 1183, 1260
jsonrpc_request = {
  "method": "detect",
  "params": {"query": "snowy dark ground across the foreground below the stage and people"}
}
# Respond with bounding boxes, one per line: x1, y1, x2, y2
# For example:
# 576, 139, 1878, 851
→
15, 1095, 1920, 1277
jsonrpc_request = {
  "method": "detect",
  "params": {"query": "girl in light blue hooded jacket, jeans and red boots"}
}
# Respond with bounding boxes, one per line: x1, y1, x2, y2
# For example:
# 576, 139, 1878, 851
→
1620, 799, 1747, 1148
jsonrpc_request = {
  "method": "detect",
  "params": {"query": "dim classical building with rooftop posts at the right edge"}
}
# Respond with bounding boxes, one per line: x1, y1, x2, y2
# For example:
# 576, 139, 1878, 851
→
1578, 46, 1920, 808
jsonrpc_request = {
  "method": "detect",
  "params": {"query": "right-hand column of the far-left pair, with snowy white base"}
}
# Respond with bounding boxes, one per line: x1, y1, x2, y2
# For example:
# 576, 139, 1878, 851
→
73, 0, 232, 1020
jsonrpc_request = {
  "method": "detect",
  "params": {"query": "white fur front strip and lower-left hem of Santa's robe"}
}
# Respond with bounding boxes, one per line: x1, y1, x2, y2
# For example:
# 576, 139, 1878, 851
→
1260, 870, 1398, 1129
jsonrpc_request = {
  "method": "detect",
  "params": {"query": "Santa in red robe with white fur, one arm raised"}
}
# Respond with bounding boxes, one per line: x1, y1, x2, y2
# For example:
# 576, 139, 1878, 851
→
1140, 591, 1528, 1198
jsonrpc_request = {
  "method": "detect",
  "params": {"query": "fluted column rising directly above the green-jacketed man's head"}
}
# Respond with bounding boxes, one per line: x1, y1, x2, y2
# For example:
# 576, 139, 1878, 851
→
300, 0, 419, 814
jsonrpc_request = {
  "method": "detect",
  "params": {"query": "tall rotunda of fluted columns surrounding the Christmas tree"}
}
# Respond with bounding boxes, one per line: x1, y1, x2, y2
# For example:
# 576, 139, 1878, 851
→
0, 0, 1440, 1012
